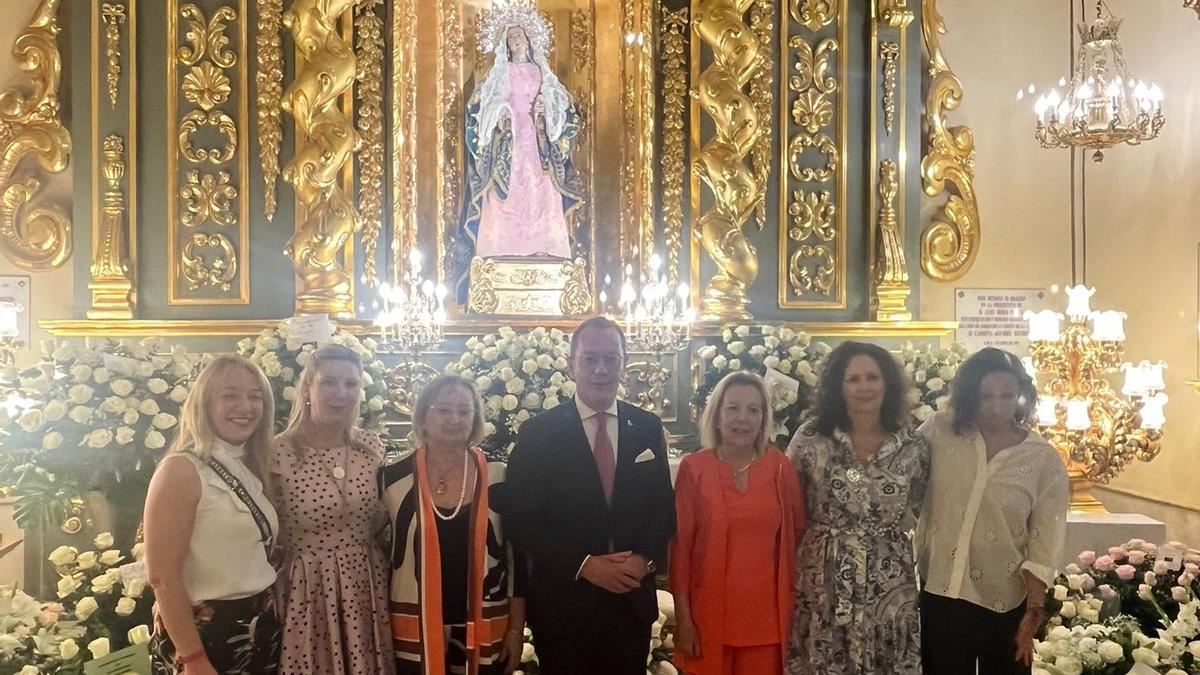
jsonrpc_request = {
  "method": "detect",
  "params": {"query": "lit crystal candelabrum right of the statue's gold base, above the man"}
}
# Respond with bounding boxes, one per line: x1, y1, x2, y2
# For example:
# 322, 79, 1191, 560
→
618, 253, 696, 354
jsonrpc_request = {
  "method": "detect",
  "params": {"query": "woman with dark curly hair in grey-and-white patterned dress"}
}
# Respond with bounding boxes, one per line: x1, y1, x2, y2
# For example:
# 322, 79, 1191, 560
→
787, 342, 929, 675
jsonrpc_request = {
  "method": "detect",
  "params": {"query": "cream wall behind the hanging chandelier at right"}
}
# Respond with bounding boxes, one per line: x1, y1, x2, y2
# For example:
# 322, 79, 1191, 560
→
920, 0, 1200, 509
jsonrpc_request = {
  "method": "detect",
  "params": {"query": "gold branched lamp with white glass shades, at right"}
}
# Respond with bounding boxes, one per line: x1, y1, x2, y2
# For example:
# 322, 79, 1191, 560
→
1024, 285, 1166, 513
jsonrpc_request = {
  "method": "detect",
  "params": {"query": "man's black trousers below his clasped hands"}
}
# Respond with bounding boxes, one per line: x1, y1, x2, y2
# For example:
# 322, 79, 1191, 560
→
533, 598, 650, 675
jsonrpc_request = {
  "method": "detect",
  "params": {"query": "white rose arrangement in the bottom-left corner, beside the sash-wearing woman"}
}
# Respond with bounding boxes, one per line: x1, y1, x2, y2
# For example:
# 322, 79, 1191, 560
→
0, 533, 154, 675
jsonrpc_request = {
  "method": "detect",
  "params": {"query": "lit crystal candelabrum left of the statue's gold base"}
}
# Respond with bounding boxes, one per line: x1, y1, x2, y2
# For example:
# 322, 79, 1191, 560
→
374, 249, 446, 360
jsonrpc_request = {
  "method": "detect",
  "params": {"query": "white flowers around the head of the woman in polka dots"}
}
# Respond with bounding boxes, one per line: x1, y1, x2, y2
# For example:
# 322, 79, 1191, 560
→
238, 321, 389, 434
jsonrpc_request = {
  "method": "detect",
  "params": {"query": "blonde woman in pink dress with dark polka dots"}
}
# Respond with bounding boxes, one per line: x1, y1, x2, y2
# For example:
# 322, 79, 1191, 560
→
271, 345, 395, 675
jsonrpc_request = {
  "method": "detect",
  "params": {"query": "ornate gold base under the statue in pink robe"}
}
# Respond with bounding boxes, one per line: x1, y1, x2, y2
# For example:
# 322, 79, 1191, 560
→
467, 258, 592, 316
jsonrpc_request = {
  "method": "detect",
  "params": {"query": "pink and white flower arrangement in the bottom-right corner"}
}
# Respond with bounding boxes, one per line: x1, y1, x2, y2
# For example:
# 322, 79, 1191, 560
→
1033, 539, 1200, 675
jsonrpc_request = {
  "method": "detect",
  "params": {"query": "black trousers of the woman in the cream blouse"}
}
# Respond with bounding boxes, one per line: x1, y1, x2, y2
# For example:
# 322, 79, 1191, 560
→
920, 591, 1031, 675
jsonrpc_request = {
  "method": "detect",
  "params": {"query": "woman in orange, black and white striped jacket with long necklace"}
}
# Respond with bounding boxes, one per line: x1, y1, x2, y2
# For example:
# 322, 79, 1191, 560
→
380, 375, 524, 675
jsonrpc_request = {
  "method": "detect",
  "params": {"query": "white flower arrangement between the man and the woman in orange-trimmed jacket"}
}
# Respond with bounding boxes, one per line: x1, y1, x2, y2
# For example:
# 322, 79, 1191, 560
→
446, 325, 580, 460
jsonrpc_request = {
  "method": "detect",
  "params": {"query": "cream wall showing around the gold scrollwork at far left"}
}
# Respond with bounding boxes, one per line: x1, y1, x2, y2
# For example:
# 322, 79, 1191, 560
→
0, 0, 75, 365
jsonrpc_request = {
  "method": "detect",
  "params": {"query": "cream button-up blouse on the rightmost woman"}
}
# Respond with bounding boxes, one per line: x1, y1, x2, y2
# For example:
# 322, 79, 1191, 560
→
917, 412, 1069, 613
